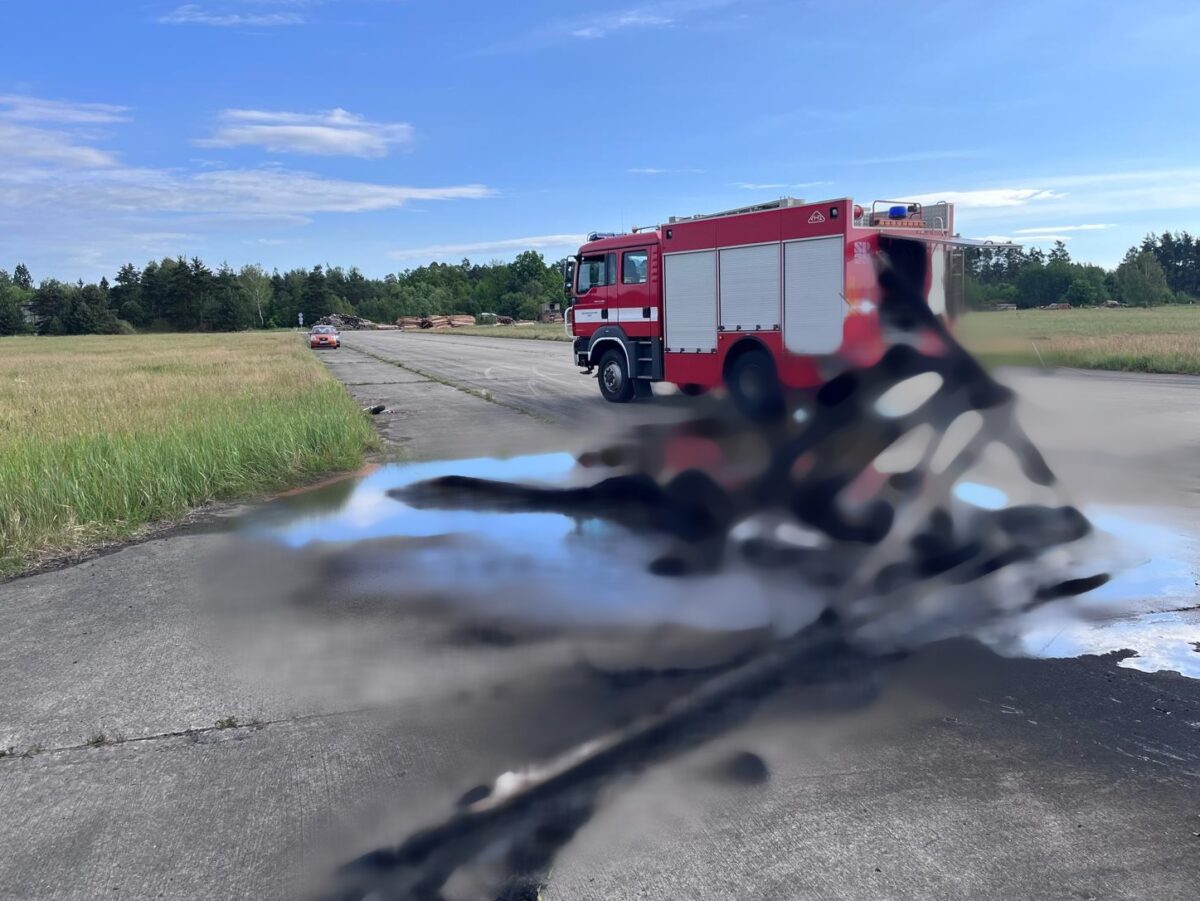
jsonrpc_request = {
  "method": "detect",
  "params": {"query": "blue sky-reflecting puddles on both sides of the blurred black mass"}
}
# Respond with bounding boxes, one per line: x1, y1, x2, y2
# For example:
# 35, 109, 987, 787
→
242, 453, 1200, 678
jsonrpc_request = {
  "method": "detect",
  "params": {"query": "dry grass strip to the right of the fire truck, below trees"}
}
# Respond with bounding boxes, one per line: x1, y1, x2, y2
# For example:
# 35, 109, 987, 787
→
958, 306, 1200, 374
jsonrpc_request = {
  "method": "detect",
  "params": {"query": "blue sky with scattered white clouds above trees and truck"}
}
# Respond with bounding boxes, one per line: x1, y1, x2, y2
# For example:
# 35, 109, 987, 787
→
0, 0, 1200, 281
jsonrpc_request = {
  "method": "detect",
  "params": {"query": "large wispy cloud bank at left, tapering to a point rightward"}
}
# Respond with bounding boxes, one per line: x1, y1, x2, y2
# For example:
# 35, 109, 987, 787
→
0, 92, 494, 274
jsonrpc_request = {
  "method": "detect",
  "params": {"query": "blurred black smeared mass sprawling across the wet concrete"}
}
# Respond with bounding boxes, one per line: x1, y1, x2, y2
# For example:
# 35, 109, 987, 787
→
330, 239, 1103, 899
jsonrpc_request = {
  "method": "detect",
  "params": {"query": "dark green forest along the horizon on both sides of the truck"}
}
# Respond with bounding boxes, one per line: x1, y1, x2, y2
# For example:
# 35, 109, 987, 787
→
0, 232, 1200, 335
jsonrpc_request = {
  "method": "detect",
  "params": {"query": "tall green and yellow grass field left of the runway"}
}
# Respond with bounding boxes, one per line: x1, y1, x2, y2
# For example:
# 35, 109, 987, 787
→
0, 332, 377, 575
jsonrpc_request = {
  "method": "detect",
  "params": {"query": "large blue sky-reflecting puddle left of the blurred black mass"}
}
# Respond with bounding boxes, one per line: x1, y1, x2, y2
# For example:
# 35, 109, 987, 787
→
242, 453, 822, 633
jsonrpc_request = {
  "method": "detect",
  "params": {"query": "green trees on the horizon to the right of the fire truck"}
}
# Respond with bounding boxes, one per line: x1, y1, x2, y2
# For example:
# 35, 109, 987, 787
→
965, 232, 1200, 310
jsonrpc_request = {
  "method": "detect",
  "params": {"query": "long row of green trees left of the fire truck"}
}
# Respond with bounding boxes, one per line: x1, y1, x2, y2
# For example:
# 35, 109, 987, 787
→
0, 251, 563, 335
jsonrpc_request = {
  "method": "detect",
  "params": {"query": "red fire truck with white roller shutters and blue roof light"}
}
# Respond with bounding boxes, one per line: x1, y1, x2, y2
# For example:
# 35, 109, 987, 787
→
564, 198, 982, 415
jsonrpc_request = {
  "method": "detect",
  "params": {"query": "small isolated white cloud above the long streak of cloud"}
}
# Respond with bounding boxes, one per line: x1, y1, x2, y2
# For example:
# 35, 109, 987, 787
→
193, 109, 413, 157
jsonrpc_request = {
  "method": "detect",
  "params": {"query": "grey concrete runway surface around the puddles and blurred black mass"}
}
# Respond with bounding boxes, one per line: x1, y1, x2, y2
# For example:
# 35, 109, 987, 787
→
0, 332, 1200, 900
